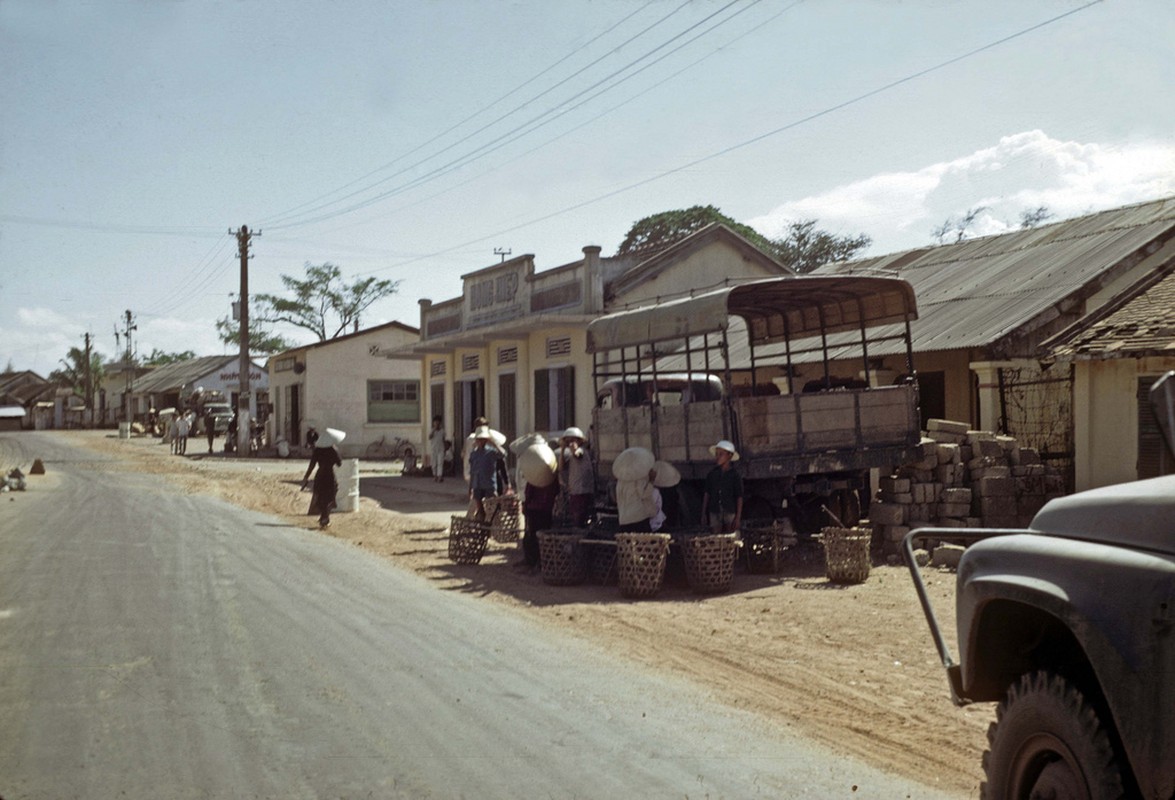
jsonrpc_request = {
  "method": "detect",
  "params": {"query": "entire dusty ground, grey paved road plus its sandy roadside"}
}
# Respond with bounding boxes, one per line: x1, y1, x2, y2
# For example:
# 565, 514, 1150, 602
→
0, 432, 992, 800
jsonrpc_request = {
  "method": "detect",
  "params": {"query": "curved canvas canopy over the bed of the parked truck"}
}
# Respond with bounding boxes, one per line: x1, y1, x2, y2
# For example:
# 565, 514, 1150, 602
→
588, 276, 918, 352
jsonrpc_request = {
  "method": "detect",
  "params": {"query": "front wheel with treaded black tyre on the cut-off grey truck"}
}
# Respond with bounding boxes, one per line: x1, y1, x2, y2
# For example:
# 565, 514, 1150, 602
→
980, 670, 1124, 800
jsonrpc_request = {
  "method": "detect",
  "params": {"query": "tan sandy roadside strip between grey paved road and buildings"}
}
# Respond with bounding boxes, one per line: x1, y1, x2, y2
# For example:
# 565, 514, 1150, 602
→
43, 431, 994, 796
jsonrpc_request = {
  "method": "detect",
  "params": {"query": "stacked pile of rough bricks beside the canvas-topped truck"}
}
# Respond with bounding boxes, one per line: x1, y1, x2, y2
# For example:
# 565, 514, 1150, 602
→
870, 419, 1065, 552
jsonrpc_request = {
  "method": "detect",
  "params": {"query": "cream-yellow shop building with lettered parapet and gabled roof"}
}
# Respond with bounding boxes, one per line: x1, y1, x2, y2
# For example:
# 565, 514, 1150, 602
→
387, 224, 790, 467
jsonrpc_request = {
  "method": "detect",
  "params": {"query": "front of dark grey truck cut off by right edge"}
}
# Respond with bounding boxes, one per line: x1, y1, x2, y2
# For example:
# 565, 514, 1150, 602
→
902, 372, 1175, 800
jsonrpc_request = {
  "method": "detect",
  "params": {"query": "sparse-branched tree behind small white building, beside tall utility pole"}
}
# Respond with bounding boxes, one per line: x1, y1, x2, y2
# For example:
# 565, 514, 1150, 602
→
249, 262, 400, 340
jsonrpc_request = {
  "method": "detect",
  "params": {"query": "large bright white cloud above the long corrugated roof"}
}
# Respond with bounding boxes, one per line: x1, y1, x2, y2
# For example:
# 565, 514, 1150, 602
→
746, 130, 1175, 255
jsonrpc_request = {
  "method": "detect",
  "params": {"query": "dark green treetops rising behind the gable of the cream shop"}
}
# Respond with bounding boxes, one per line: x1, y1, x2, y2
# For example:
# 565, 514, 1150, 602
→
616, 206, 873, 273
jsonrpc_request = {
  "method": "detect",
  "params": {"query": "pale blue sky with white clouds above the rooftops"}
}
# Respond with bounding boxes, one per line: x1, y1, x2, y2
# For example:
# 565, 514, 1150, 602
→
0, 0, 1175, 376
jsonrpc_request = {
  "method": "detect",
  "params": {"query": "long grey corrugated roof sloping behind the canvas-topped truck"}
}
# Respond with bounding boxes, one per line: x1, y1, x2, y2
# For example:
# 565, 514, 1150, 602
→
815, 197, 1175, 355
